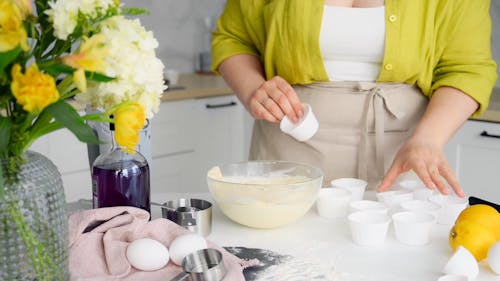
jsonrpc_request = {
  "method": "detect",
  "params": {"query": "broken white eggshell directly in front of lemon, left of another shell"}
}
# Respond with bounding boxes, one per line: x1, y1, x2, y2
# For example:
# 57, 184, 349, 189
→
443, 246, 479, 280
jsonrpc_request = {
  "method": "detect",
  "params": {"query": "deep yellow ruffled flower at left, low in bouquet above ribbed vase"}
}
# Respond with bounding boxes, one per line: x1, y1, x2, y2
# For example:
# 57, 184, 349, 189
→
10, 64, 59, 113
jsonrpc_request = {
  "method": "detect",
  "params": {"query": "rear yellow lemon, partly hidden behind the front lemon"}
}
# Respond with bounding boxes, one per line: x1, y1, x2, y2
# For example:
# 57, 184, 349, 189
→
455, 204, 500, 240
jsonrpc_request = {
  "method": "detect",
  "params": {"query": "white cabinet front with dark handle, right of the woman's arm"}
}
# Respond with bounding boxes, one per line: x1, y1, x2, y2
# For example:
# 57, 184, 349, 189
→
445, 120, 500, 203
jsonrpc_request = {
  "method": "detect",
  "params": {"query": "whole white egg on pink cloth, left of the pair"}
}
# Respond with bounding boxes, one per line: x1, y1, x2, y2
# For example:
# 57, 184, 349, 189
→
127, 238, 169, 271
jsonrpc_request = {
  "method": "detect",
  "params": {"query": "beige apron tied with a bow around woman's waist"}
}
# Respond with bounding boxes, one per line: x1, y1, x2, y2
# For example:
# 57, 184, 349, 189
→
250, 82, 428, 188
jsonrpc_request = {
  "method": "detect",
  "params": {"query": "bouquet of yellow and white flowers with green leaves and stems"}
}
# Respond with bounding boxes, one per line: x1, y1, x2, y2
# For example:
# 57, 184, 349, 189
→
0, 0, 166, 280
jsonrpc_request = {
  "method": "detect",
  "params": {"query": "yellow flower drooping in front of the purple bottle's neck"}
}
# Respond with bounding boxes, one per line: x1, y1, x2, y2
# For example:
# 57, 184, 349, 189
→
113, 103, 146, 153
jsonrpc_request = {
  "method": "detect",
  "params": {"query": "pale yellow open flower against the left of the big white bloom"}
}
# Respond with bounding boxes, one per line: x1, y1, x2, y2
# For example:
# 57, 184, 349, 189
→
62, 34, 109, 92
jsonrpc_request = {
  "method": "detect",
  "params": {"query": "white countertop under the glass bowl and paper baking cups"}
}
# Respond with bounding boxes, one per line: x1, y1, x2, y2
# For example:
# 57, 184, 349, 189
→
148, 193, 500, 281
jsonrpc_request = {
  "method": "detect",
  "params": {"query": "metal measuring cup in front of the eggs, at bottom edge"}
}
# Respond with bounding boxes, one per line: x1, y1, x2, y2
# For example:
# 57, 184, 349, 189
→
170, 249, 226, 281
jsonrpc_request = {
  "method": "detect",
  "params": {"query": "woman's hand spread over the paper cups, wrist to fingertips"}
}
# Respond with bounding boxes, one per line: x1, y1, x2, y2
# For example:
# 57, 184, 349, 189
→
377, 140, 465, 197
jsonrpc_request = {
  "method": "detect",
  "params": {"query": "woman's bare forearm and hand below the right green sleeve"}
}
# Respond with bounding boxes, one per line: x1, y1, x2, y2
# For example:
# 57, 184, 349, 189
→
378, 87, 478, 197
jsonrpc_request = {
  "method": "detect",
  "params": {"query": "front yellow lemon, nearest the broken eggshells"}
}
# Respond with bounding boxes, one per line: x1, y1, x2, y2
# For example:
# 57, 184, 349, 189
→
448, 219, 497, 261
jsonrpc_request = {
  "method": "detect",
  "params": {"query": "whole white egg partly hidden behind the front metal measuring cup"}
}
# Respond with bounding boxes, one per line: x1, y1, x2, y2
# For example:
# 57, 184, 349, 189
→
169, 233, 207, 265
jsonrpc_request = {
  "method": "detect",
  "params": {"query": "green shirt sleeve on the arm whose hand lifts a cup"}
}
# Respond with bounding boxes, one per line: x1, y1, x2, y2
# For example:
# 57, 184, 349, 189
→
212, 0, 259, 73
